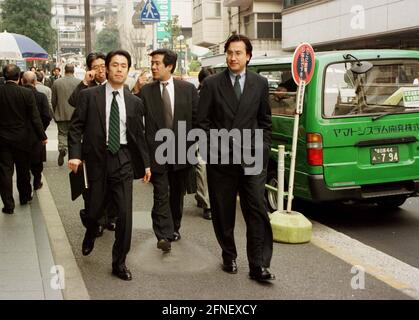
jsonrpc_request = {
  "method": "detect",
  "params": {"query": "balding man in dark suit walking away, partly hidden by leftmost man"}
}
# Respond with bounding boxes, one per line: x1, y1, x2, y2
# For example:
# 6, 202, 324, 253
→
22, 71, 51, 190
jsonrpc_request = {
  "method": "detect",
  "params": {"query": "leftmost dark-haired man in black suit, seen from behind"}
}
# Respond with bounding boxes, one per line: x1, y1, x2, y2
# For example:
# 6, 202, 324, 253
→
0, 64, 48, 214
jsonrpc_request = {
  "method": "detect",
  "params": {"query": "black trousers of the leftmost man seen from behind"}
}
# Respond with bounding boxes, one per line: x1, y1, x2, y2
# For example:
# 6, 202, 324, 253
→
0, 144, 32, 209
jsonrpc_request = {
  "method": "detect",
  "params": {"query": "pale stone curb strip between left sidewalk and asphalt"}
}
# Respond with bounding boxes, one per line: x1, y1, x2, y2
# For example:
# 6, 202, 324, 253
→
36, 177, 90, 300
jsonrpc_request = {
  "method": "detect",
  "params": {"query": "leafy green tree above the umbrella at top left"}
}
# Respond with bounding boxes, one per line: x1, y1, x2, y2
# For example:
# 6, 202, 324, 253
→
0, 0, 56, 53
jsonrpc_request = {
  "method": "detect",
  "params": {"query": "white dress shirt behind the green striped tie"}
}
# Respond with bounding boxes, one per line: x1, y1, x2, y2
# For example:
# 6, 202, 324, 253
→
106, 82, 127, 144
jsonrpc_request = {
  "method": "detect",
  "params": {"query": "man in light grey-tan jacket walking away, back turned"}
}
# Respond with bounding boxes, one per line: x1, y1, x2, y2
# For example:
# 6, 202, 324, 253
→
51, 64, 80, 166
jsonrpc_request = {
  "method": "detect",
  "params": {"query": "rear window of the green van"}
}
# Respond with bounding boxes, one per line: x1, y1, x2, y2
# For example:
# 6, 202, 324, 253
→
323, 59, 419, 118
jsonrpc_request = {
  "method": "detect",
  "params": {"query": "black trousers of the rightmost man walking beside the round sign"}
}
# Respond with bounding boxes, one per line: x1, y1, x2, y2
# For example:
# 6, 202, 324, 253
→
207, 165, 273, 267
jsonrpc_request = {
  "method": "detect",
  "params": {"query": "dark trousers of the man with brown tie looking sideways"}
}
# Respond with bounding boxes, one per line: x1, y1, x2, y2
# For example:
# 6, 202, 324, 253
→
151, 168, 190, 240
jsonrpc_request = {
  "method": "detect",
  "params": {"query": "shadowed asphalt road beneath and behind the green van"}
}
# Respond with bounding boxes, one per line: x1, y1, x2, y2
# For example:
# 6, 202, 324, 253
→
299, 198, 419, 268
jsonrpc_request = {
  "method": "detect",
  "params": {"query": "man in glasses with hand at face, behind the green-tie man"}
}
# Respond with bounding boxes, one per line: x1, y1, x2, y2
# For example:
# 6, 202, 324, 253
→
68, 52, 117, 237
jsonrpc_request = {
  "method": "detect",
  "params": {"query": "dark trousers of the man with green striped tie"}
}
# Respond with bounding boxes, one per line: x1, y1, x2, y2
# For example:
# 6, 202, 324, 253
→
86, 147, 134, 266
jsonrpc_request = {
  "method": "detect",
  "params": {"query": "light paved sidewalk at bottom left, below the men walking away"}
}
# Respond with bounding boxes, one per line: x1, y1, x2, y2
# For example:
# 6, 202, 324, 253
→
0, 183, 63, 300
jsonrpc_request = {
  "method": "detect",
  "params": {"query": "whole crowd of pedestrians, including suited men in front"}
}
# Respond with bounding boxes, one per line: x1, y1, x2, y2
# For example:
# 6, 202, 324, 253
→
0, 34, 275, 281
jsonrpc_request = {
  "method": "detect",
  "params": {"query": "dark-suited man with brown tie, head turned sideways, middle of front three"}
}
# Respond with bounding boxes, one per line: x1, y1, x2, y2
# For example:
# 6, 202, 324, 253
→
139, 49, 198, 252
